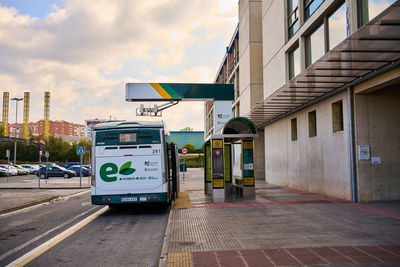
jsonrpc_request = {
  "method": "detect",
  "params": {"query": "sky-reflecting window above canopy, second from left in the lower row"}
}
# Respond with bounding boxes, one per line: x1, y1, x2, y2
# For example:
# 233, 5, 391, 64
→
306, 24, 325, 67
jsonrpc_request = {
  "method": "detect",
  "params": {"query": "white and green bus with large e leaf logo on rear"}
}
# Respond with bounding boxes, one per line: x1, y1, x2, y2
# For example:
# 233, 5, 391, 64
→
91, 121, 179, 206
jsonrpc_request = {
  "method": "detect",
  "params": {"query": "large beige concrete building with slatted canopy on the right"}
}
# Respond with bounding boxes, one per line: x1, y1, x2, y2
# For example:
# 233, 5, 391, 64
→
211, 0, 400, 202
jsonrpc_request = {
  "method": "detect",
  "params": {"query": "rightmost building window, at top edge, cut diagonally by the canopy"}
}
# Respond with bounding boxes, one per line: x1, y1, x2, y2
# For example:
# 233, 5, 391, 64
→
358, 0, 396, 27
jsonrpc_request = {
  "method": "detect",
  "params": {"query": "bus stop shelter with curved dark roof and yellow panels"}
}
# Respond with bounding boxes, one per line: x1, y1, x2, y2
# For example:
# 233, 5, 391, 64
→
204, 117, 258, 203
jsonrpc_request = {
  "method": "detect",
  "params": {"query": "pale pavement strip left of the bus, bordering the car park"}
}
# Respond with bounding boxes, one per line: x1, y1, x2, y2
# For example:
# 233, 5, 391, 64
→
0, 177, 90, 215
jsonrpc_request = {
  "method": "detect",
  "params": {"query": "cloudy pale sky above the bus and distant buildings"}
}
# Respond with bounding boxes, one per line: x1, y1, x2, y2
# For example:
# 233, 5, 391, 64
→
0, 0, 238, 130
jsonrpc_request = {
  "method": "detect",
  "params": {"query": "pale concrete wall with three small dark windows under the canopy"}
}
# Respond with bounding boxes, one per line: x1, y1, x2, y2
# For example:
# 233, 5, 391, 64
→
264, 92, 351, 199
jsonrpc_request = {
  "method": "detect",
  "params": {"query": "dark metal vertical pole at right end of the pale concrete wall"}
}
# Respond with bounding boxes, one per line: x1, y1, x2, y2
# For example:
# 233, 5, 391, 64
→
347, 87, 358, 202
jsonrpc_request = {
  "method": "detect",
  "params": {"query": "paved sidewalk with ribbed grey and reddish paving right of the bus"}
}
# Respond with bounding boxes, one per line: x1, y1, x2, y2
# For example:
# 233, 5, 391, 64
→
161, 170, 400, 266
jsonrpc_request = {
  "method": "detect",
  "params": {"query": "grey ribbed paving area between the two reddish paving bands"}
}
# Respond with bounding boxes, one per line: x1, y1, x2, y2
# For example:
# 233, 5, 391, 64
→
168, 204, 400, 252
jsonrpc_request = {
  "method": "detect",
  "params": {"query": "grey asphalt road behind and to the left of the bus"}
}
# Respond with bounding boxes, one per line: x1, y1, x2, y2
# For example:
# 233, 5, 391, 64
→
0, 193, 169, 266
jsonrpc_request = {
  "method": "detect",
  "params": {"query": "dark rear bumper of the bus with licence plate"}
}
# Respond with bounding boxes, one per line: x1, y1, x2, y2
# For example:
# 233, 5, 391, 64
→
92, 193, 168, 205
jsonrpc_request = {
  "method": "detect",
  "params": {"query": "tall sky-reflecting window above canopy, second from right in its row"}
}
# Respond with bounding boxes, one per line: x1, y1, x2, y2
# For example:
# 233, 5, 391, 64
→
328, 3, 349, 50
